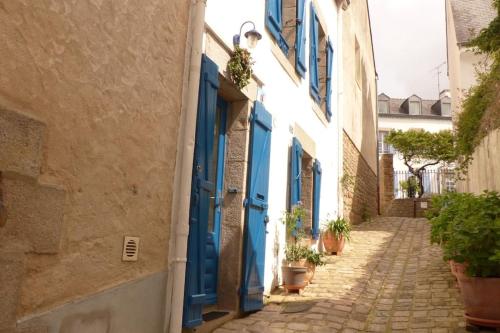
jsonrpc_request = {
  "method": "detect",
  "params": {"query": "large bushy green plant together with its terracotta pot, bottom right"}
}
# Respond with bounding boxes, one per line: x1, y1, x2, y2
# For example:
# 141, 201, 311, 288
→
431, 192, 500, 327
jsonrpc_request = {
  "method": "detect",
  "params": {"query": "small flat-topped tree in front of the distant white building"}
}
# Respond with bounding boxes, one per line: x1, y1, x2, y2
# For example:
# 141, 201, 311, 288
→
385, 129, 456, 198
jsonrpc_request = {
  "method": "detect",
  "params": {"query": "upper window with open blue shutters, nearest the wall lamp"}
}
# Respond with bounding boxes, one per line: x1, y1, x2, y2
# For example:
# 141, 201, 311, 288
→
266, 0, 306, 78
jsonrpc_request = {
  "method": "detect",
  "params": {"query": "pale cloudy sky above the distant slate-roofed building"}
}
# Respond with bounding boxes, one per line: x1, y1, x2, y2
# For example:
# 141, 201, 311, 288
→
368, 0, 448, 99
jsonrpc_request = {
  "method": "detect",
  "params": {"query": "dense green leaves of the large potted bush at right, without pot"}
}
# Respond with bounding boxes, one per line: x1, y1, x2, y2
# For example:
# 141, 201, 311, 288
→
429, 192, 500, 277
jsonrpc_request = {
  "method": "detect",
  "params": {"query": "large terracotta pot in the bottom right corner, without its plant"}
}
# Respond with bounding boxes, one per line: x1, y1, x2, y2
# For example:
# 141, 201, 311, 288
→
452, 262, 500, 328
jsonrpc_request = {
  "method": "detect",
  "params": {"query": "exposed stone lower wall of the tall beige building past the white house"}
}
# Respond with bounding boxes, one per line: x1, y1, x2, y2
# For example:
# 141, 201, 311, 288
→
341, 132, 378, 224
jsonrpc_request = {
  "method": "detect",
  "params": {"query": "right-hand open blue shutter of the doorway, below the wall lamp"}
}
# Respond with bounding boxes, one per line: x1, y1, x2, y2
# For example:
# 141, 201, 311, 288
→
241, 102, 272, 312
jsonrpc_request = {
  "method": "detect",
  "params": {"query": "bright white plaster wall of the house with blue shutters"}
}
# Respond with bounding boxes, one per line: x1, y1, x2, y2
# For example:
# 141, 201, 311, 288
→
206, 0, 341, 292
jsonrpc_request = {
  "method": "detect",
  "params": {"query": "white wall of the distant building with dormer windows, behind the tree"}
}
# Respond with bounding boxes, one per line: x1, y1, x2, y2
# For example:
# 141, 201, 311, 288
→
378, 116, 452, 171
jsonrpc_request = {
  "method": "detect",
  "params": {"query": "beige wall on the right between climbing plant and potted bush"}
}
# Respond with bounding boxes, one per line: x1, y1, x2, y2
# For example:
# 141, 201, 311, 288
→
457, 128, 500, 194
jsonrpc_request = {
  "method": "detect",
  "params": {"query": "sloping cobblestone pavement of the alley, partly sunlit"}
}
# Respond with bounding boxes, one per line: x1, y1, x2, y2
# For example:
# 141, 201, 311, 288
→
214, 218, 472, 333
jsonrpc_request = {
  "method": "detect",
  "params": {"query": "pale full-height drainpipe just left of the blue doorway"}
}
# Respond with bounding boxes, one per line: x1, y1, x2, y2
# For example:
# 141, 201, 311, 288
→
163, 0, 206, 333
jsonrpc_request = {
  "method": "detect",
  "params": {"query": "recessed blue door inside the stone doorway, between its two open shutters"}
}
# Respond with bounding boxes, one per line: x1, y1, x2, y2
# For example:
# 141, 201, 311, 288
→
204, 97, 227, 304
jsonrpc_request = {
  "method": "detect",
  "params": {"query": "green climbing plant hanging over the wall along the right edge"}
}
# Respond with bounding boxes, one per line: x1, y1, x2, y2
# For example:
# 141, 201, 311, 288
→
456, 0, 500, 174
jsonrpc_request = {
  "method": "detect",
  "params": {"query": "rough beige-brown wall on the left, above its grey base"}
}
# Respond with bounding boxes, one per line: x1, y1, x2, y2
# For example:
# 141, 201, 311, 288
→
0, 0, 189, 331
